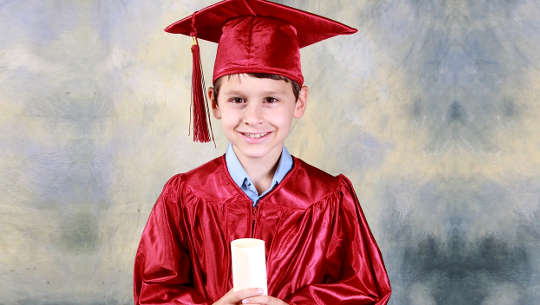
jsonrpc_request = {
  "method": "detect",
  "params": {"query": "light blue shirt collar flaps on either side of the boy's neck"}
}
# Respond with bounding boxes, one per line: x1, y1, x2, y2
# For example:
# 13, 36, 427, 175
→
225, 144, 293, 188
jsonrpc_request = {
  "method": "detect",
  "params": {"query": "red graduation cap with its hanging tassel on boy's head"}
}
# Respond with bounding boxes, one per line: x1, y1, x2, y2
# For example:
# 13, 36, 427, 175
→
165, 0, 356, 142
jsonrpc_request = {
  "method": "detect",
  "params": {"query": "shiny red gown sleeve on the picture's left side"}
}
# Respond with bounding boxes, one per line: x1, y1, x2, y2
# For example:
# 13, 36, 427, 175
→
133, 175, 210, 305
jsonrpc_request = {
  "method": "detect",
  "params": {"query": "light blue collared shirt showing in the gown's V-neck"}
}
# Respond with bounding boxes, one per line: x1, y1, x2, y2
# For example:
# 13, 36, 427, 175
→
225, 144, 293, 206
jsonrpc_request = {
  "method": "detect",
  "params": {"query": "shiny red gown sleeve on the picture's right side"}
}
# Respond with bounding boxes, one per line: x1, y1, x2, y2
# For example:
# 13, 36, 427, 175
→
285, 175, 391, 305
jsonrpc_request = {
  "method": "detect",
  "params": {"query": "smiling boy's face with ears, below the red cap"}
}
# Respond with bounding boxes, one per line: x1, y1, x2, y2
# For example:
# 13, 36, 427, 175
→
208, 74, 307, 159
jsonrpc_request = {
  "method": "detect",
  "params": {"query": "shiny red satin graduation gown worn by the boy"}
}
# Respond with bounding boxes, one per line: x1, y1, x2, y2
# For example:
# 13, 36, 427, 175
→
134, 156, 390, 305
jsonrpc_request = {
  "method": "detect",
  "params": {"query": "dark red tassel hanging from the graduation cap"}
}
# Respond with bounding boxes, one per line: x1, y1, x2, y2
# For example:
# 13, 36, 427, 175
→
190, 36, 215, 145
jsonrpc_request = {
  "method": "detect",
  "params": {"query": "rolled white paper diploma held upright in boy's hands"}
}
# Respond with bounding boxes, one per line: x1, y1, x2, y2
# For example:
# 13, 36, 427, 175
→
231, 238, 268, 295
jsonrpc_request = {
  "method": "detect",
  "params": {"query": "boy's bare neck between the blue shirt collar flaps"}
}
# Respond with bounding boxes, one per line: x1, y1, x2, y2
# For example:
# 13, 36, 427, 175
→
233, 146, 283, 194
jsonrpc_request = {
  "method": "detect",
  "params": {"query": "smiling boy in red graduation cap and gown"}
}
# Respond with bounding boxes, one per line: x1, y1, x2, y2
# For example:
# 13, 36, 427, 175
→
134, 0, 390, 305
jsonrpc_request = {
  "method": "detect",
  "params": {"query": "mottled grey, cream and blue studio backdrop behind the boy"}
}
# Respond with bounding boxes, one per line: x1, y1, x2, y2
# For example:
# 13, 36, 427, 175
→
0, 0, 540, 305
